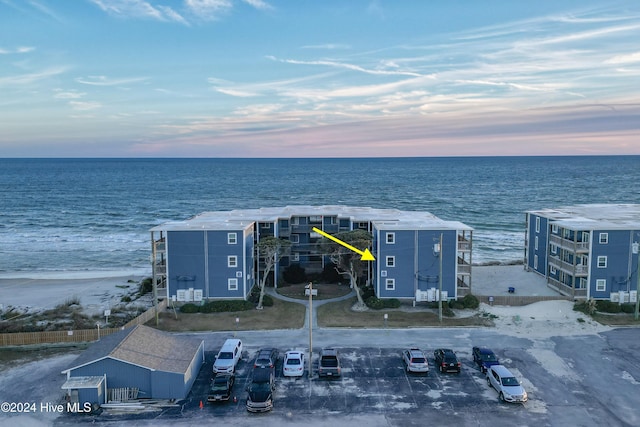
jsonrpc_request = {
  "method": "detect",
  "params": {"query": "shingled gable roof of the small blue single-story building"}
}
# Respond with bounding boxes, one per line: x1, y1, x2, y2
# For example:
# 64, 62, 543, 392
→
62, 325, 202, 374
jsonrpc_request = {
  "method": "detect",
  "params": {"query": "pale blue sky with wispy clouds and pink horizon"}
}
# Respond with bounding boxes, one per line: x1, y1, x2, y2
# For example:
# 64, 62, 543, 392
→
0, 0, 640, 158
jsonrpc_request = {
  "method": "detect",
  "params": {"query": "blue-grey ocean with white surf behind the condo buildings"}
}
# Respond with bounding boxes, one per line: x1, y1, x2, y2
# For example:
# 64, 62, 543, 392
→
0, 156, 640, 277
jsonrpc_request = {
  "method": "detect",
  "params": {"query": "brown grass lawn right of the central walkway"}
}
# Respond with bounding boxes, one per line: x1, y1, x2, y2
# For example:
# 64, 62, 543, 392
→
318, 297, 493, 328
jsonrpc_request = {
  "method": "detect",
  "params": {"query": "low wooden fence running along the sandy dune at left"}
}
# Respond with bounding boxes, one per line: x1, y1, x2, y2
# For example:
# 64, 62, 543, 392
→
0, 299, 167, 347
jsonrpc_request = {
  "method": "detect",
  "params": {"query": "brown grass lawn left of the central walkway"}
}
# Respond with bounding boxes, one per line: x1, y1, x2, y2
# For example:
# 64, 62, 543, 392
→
147, 298, 305, 332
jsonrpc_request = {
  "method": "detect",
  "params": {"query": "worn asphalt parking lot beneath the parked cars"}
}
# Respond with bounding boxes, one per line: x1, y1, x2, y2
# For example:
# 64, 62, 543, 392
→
43, 328, 640, 427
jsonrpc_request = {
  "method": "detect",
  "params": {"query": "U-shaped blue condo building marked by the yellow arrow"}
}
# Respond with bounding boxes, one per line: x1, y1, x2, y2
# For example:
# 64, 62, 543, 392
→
151, 206, 473, 301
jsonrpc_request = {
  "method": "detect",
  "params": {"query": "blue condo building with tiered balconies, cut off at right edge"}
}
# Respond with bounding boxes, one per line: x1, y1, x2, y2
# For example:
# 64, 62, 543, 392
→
525, 204, 640, 303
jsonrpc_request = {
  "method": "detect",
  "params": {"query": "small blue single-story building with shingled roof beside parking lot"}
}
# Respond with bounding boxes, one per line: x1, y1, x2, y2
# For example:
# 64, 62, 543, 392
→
62, 325, 204, 406
